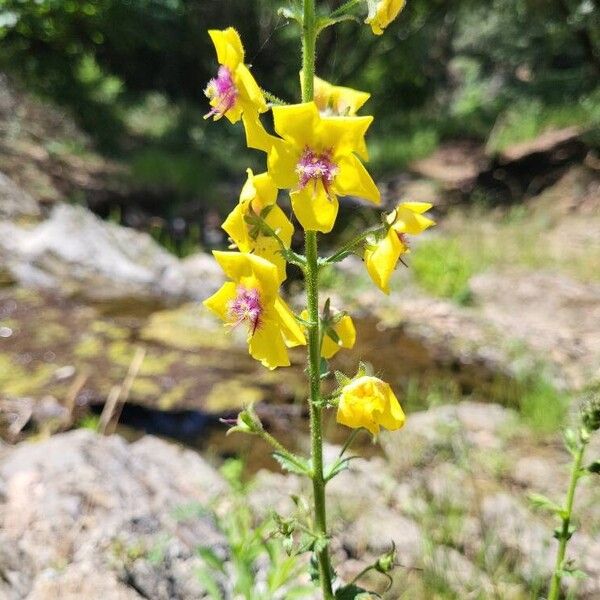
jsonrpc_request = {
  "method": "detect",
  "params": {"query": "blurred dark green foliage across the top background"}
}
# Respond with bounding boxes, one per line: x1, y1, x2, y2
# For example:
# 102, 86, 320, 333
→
0, 0, 600, 209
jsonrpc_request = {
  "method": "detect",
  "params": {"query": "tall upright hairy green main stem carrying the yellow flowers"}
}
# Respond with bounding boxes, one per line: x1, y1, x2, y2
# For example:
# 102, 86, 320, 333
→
302, 0, 333, 600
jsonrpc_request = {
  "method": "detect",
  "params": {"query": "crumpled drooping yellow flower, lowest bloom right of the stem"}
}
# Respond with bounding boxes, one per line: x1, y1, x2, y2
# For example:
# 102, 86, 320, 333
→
337, 375, 406, 435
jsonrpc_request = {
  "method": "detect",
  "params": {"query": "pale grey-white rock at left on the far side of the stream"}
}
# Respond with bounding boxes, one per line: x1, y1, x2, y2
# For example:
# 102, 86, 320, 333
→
0, 204, 223, 303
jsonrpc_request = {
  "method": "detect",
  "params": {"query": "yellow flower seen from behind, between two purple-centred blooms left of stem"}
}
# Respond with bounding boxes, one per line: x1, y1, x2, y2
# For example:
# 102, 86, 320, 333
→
222, 169, 294, 282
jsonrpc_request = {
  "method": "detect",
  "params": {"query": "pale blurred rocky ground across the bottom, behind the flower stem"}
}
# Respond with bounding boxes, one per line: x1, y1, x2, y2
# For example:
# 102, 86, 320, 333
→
0, 402, 600, 600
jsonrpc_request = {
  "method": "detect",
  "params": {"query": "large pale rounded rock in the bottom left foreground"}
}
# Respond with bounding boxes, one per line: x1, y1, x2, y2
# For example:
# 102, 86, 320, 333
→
0, 430, 226, 600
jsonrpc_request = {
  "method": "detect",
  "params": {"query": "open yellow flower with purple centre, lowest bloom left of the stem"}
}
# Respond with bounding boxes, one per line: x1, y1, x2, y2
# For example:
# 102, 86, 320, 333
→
203, 251, 306, 369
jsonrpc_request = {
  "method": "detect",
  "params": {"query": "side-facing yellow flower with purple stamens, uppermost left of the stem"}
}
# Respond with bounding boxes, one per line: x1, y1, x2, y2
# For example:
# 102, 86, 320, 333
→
204, 27, 267, 123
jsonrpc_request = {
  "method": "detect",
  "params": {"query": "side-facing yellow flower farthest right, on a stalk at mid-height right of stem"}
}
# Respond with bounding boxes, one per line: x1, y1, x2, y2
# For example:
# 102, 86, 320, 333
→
364, 202, 435, 294
